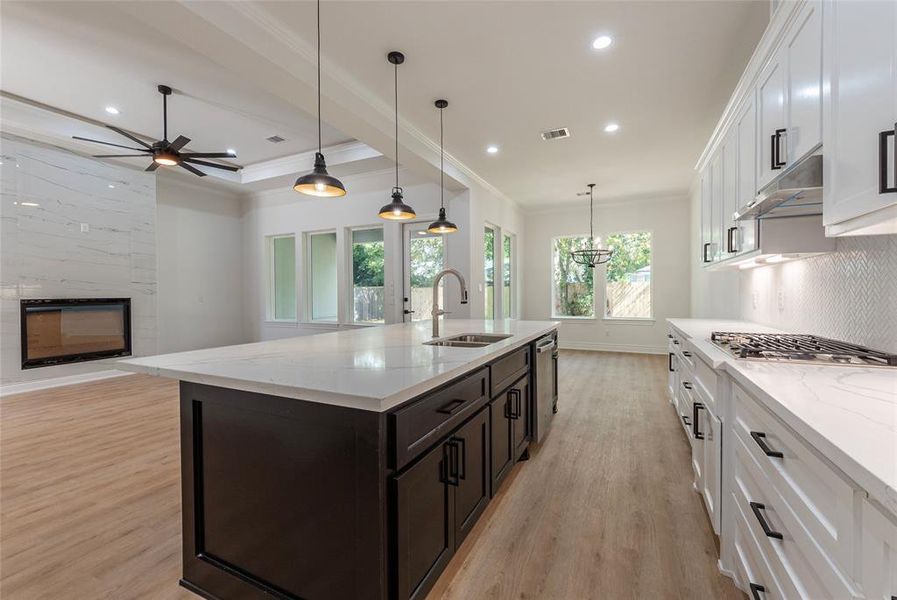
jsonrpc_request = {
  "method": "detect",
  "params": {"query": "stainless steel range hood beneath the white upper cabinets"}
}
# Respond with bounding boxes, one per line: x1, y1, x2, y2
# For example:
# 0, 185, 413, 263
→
734, 154, 822, 221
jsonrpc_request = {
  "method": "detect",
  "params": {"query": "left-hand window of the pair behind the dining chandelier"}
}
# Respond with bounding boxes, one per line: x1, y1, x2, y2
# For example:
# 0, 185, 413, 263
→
551, 236, 595, 318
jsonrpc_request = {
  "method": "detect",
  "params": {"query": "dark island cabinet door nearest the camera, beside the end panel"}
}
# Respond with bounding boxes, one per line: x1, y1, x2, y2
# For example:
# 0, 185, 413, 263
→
393, 441, 460, 600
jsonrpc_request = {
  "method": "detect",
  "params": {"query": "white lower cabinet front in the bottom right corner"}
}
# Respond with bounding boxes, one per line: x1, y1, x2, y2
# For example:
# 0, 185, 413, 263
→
862, 500, 897, 600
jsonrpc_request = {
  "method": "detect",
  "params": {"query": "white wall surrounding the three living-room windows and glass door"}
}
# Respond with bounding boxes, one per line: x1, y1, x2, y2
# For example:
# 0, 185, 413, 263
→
243, 169, 471, 340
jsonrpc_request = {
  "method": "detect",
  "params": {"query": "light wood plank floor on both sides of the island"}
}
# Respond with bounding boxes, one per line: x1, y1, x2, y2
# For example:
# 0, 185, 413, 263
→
0, 351, 744, 600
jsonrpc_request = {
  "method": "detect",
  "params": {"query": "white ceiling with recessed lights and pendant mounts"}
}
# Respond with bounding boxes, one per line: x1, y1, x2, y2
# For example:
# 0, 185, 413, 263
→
0, 0, 769, 206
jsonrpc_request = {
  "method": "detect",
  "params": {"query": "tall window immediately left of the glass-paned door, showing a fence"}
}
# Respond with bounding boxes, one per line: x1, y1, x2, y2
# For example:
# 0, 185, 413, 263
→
352, 227, 384, 323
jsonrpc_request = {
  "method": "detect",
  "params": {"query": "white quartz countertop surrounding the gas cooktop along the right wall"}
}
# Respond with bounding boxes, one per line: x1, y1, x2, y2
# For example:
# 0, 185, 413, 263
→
668, 319, 897, 514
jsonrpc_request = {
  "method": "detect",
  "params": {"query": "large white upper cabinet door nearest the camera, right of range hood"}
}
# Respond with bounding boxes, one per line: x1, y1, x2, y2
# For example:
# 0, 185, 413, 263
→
823, 0, 897, 234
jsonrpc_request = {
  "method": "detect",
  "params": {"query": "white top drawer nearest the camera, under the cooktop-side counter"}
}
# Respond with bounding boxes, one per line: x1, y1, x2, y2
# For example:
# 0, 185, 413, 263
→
733, 384, 856, 575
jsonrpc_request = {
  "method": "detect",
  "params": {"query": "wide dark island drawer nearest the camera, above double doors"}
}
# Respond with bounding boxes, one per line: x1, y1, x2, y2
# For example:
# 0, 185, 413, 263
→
389, 368, 489, 469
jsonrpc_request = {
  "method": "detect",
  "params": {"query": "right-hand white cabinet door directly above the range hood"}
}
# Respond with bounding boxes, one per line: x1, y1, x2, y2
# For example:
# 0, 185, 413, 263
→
782, 2, 822, 163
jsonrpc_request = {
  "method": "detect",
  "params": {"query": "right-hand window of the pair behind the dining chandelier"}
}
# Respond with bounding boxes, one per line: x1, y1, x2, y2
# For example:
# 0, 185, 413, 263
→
604, 231, 652, 319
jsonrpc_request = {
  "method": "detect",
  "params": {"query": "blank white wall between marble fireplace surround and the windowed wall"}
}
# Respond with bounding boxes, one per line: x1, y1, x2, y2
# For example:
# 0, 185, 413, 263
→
156, 172, 246, 353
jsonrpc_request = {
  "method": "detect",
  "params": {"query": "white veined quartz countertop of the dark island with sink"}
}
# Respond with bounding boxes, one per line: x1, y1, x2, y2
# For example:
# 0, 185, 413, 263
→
115, 319, 559, 412
